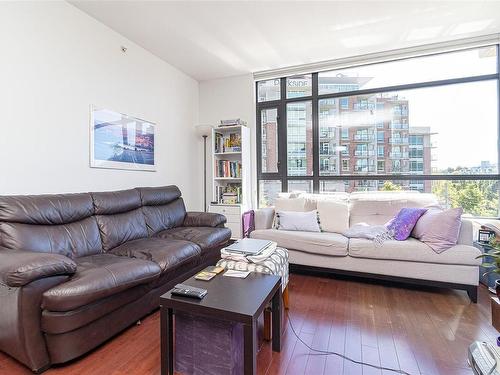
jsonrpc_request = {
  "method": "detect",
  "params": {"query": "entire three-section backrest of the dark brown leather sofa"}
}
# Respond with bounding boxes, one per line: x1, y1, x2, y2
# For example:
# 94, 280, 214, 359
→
0, 185, 186, 258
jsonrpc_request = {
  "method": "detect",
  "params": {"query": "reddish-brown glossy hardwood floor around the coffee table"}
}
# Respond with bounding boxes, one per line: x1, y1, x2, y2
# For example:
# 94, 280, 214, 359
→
0, 275, 498, 375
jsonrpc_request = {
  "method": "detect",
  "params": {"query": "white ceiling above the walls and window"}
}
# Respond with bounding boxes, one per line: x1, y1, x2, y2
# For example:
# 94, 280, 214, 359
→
70, 0, 500, 81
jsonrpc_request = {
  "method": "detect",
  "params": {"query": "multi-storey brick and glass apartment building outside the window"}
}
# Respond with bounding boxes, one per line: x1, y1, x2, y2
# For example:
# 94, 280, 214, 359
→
287, 76, 438, 192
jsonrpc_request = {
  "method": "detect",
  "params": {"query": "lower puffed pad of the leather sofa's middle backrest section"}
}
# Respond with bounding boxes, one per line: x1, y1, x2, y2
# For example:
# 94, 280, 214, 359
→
96, 208, 148, 251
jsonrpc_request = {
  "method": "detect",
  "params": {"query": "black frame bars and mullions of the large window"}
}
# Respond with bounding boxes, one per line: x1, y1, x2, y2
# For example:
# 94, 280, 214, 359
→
255, 44, 500, 217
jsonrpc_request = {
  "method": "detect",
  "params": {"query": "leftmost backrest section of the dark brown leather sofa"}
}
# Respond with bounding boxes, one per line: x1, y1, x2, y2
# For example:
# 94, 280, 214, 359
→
0, 193, 103, 258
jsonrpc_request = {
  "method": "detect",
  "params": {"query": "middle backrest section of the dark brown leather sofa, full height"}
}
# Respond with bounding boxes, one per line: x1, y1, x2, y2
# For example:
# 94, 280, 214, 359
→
90, 189, 148, 251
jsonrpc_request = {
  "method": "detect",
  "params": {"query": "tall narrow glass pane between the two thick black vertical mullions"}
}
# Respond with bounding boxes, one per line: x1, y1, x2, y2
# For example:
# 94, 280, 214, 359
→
286, 101, 313, 176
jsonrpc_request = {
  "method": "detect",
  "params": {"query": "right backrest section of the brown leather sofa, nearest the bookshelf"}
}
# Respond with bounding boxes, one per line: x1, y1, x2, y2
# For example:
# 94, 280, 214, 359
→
137, 185, 186, 236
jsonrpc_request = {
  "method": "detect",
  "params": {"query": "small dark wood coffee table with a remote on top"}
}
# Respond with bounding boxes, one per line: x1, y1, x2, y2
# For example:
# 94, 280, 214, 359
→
160, 272, 281, 375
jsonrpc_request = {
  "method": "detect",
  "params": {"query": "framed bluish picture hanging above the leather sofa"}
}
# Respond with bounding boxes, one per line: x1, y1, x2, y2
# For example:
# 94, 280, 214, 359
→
90, 106, 156, 171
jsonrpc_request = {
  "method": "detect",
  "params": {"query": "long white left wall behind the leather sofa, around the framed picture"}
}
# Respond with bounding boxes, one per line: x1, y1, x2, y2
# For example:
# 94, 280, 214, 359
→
0, 2, 203, 209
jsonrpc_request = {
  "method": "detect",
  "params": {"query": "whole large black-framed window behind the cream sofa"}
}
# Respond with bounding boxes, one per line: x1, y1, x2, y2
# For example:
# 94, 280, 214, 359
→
257, 45, 500, 216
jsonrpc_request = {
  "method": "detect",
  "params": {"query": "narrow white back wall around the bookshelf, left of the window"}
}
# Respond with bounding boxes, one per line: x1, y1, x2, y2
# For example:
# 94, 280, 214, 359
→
199, 74, 257, 207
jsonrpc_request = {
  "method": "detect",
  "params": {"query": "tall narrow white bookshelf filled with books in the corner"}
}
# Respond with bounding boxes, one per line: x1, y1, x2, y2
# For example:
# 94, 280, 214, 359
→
209, 125, 251, 239
